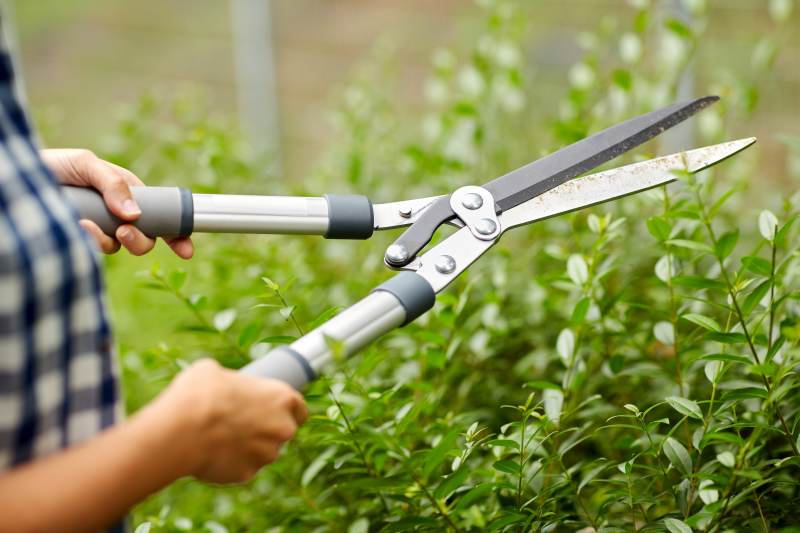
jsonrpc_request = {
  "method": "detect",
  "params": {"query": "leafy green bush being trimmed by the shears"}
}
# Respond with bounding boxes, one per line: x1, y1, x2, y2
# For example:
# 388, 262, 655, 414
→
109, 0, 800, 533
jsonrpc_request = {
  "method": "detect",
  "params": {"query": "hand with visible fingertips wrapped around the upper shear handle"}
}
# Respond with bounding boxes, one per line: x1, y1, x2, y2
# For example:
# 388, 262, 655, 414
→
40, 149, 194, 259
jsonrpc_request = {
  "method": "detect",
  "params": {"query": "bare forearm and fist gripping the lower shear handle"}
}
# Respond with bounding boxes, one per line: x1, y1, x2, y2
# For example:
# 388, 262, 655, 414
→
0, 360, 307, 532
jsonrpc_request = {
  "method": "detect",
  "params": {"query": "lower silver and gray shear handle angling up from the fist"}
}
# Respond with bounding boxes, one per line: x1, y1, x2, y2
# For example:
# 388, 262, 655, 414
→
241, 272, 436, 390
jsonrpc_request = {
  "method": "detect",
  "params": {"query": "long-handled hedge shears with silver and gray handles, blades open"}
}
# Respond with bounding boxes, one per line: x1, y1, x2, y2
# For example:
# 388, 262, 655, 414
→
64, 96, 756, 390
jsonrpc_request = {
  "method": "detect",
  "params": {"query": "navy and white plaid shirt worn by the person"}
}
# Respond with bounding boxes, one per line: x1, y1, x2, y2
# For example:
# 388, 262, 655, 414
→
0, 26, 121, 471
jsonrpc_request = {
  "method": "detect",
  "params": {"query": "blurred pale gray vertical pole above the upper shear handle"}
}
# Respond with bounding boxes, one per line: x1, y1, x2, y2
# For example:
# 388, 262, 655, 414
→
230, 0, 282, 173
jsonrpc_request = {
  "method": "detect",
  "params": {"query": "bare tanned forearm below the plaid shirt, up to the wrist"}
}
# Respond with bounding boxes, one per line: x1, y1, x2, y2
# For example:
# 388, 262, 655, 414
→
0, 405, 190, 531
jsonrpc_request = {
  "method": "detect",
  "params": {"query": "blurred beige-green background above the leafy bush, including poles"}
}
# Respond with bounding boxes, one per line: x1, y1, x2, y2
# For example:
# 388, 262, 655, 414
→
5, 0, 800, 181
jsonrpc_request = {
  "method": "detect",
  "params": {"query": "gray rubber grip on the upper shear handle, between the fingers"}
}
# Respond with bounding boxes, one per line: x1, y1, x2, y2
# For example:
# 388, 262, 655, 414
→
62, 185, 194, 238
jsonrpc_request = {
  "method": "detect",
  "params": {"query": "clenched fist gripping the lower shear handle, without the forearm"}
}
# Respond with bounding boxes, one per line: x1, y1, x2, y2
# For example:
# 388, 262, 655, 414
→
151, 359, 308, 483
